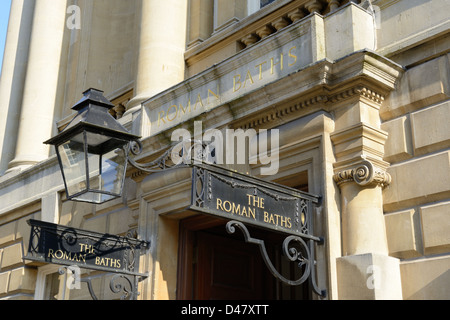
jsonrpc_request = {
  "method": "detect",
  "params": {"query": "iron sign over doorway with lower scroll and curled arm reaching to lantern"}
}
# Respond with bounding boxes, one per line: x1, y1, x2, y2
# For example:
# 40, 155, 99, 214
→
129, 140, 327, 298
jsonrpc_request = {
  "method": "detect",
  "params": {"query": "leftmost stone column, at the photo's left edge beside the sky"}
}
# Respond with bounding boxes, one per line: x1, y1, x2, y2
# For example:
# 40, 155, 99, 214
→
0, 0, 34, 175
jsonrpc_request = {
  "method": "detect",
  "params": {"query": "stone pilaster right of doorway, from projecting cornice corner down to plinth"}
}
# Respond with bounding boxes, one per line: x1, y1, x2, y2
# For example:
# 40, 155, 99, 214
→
329, 48, 402, 299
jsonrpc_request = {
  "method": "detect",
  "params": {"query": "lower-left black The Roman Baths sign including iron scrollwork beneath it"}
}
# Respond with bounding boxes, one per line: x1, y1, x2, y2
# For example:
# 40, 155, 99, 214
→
24, 220, 150, 300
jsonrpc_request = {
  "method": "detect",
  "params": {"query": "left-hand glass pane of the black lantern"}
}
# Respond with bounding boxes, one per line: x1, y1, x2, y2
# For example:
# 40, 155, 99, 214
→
58, 133, 87, 197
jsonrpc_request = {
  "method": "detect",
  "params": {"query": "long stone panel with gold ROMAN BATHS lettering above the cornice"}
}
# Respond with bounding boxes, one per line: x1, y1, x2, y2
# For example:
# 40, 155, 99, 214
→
143, 15, 324, 135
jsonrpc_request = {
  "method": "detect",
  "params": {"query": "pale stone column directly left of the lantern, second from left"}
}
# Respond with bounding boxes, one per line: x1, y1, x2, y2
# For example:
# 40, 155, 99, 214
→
9, 0, 67, 169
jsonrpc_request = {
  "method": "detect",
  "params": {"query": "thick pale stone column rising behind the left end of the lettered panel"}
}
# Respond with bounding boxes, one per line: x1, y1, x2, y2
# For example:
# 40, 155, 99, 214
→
125, 0, 187, 116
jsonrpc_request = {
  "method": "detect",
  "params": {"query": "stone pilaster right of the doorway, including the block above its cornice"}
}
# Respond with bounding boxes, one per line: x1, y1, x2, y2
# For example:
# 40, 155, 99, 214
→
325, 5, 402, 299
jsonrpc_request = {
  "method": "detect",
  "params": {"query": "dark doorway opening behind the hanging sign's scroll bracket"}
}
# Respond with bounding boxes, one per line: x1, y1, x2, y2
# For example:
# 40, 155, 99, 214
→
177, 215, 310, 300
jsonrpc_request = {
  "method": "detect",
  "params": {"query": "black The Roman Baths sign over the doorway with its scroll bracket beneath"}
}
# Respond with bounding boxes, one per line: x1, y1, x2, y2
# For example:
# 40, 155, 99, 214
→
190, 165, 326, 297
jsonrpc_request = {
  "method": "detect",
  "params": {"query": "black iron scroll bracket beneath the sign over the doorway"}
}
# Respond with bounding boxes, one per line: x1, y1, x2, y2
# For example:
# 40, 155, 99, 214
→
226, 221, 326, 298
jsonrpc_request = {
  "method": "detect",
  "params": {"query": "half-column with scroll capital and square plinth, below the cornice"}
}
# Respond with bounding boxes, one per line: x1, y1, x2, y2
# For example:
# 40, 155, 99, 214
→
333, 119, 402, 300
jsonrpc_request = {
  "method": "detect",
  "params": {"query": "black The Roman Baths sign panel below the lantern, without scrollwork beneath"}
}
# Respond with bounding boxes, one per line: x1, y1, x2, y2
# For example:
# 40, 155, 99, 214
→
24, 220, 148, 274
